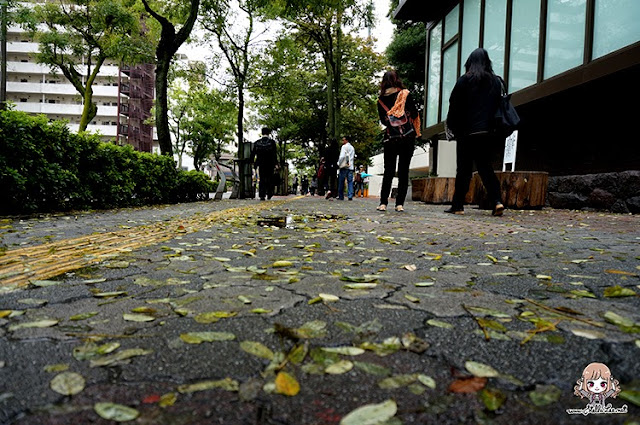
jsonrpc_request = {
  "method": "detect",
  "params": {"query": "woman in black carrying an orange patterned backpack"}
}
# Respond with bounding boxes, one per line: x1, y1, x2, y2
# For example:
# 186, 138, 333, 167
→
377, 71, 420, 212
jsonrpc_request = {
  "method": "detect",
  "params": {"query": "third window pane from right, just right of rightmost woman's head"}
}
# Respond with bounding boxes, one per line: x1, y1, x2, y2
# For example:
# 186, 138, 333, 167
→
508, 0, 540, 92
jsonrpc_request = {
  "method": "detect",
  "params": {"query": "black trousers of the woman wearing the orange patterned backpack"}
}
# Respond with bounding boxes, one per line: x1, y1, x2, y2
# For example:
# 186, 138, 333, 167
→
380, 137, 415, 205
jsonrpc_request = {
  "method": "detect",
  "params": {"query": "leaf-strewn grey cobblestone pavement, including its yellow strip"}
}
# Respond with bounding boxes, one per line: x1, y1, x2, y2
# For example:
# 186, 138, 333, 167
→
0, 197, 640, 425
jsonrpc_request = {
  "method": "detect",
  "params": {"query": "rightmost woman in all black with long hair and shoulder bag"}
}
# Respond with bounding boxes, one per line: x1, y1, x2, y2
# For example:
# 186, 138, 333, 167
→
445, 48, 504, 216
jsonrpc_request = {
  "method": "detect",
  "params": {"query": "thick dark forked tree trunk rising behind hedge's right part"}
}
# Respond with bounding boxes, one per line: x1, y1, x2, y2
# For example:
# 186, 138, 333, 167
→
142, 0, 200, 156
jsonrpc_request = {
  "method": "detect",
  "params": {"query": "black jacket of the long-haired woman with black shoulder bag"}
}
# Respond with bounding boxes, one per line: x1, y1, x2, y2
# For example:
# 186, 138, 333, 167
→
447, 74, 501, 137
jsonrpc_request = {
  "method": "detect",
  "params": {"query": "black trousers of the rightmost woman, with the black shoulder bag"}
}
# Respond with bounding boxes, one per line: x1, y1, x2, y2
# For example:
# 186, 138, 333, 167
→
451, 133, 502, 209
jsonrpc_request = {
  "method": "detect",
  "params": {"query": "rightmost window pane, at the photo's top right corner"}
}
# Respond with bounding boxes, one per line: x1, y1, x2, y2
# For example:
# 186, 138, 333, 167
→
593, 0, 640, 59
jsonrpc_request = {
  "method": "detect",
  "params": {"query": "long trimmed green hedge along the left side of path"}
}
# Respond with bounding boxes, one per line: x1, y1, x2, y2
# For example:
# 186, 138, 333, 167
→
0, 111, 214, 215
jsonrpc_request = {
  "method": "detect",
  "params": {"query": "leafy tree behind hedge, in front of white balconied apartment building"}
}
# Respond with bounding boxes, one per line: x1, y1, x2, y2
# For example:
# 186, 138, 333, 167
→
18, 0, 152, 131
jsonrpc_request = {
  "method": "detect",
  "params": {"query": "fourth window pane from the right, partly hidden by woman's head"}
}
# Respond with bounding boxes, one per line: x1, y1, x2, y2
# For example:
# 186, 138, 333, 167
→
484, 0, 507, 75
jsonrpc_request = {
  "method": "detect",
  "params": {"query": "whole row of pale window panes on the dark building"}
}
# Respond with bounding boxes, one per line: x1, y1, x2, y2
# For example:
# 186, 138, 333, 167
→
425, 0, 640, 127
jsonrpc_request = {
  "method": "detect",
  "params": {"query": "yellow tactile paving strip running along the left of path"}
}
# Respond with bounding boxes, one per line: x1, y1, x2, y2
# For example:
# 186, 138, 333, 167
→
0, 200, 287, 286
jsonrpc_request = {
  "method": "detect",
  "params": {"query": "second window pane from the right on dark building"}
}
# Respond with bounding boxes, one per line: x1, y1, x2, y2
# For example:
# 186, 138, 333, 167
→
544, 0, 587, 78
